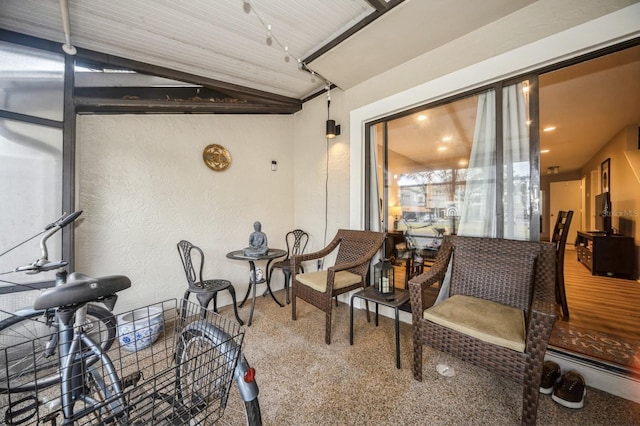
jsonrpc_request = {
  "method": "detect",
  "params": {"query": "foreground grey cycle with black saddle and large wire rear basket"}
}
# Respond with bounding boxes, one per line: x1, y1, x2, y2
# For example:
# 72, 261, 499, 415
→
0, 211, 261, 425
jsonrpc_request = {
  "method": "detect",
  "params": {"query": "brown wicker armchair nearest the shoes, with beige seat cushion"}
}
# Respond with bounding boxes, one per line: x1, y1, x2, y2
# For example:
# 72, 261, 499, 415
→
409, 236, 556, 424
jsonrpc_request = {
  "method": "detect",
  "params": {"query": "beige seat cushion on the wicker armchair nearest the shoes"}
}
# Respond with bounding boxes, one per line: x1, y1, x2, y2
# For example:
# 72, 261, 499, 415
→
423, 294, 525, 352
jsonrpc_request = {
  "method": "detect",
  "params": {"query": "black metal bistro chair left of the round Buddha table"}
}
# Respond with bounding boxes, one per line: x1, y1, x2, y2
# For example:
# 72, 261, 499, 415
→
178, 240, 244, 325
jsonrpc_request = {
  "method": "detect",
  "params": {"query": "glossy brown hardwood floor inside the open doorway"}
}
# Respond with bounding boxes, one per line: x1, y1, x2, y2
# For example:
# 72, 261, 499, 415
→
558, 250, 640, 340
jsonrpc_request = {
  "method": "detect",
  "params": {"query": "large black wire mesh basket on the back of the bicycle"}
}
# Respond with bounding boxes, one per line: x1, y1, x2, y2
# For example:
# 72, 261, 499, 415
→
0, 299, 244, 425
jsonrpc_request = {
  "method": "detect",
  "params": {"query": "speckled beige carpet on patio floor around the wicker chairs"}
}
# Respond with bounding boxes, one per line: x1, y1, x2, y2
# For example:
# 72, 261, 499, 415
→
220, 288, 640, 425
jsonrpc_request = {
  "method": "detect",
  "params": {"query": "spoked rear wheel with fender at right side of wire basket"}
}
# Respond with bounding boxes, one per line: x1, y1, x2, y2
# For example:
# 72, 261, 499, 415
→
176, 322, 262, 426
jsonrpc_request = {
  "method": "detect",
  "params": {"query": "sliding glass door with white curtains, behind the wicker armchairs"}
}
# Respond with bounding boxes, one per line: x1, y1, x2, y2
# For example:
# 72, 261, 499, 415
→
368, 80, 539, 253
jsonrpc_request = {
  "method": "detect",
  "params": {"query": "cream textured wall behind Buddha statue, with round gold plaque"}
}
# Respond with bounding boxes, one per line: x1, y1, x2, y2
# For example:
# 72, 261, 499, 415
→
76, 115, 294, 311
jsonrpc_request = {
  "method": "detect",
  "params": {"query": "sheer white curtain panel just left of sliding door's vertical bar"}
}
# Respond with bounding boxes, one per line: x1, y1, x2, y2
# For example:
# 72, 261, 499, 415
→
458, 90, 497, 237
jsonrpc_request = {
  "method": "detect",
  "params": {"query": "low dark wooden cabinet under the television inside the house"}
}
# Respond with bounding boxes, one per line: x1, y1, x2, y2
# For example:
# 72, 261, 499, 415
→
576, 231, 635, 278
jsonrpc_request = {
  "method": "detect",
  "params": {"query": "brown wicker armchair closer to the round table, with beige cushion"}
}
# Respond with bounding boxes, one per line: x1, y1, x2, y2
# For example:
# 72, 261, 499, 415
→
290, 229, 385, 345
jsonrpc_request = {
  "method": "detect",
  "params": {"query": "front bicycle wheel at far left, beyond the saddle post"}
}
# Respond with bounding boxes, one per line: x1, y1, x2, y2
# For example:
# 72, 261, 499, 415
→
0, 304, 117, 392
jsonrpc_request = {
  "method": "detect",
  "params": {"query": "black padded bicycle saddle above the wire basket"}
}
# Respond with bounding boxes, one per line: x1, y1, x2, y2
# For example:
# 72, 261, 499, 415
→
33, 272, 131, 309
